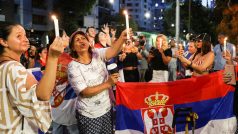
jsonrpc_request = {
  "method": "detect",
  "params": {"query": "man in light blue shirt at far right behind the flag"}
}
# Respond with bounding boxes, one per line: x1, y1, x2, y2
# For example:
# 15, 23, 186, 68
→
213, 33, 236, 71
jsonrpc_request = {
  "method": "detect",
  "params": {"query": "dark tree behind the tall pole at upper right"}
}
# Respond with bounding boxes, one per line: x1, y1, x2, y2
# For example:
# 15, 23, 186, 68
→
164, 0, 215, 41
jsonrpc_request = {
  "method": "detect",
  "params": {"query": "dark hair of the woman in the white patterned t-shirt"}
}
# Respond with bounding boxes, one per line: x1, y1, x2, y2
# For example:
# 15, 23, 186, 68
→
69, 31, 92, 58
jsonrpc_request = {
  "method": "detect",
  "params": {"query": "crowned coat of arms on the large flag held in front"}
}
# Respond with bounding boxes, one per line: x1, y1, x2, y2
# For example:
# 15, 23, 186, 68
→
141, 92, 174, 134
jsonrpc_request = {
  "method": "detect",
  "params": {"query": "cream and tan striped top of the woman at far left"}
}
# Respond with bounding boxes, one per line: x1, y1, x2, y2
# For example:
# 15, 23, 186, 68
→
0, 61, 51, 134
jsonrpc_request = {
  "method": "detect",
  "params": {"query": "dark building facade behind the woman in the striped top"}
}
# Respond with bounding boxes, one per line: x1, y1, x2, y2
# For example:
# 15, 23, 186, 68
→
0, 0, 53, 45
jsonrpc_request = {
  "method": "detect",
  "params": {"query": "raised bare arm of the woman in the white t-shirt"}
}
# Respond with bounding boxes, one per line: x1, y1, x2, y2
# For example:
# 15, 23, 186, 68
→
106, 30, 127, 60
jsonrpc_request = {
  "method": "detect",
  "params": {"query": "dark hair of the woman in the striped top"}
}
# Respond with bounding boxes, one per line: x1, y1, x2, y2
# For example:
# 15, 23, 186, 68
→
0, 22, 20, 55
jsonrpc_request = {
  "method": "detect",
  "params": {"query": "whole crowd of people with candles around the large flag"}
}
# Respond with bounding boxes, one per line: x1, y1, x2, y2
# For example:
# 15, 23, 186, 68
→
0, 22, 236, 134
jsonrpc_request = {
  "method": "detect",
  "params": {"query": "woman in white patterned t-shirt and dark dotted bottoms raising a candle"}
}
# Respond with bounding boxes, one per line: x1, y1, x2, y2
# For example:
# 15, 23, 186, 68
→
68, 31, 126, 134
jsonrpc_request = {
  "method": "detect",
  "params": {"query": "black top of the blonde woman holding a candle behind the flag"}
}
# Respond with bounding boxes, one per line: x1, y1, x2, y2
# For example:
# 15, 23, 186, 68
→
151, 49, 172, 70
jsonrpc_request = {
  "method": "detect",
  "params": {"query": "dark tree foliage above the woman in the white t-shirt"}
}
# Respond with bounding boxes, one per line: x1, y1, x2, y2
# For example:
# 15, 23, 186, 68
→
54, 0, 96, 34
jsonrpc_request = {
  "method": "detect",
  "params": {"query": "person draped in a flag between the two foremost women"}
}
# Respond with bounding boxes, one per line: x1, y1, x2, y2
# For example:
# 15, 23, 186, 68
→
48, 29, 79, 134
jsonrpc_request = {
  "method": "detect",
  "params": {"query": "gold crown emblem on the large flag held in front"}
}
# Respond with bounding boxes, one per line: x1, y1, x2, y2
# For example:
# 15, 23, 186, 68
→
145, 92, 169, 107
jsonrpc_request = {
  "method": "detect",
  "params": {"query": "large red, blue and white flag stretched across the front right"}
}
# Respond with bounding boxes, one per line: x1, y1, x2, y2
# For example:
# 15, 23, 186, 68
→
116, 71, 236, 134
